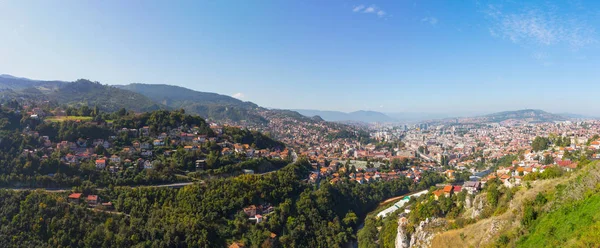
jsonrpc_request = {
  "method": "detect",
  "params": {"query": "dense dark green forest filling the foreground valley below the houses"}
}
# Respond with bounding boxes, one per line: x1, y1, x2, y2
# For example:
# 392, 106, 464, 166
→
0, 159, 440, 247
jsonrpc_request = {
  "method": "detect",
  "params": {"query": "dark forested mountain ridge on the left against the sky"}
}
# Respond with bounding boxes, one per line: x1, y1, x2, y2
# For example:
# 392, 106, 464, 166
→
0, 75, 323, 125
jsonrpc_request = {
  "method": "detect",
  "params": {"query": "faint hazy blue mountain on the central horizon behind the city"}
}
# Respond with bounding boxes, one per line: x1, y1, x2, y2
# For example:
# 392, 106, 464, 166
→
294, 109, 396, 123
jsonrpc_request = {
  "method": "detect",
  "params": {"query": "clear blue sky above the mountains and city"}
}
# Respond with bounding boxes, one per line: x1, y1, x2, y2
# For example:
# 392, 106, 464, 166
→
0, 0, 600, 115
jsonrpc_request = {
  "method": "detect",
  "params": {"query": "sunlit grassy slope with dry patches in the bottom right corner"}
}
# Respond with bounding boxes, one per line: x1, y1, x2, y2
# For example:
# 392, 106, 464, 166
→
432, 163, 600, 247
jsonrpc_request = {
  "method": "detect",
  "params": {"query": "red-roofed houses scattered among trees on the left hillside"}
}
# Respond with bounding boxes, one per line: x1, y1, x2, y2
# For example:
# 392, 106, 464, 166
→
23, 117, 290, 175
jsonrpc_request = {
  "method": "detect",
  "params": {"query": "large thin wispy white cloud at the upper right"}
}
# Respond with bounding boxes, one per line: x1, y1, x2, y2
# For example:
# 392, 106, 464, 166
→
483, 5, 597, 50
